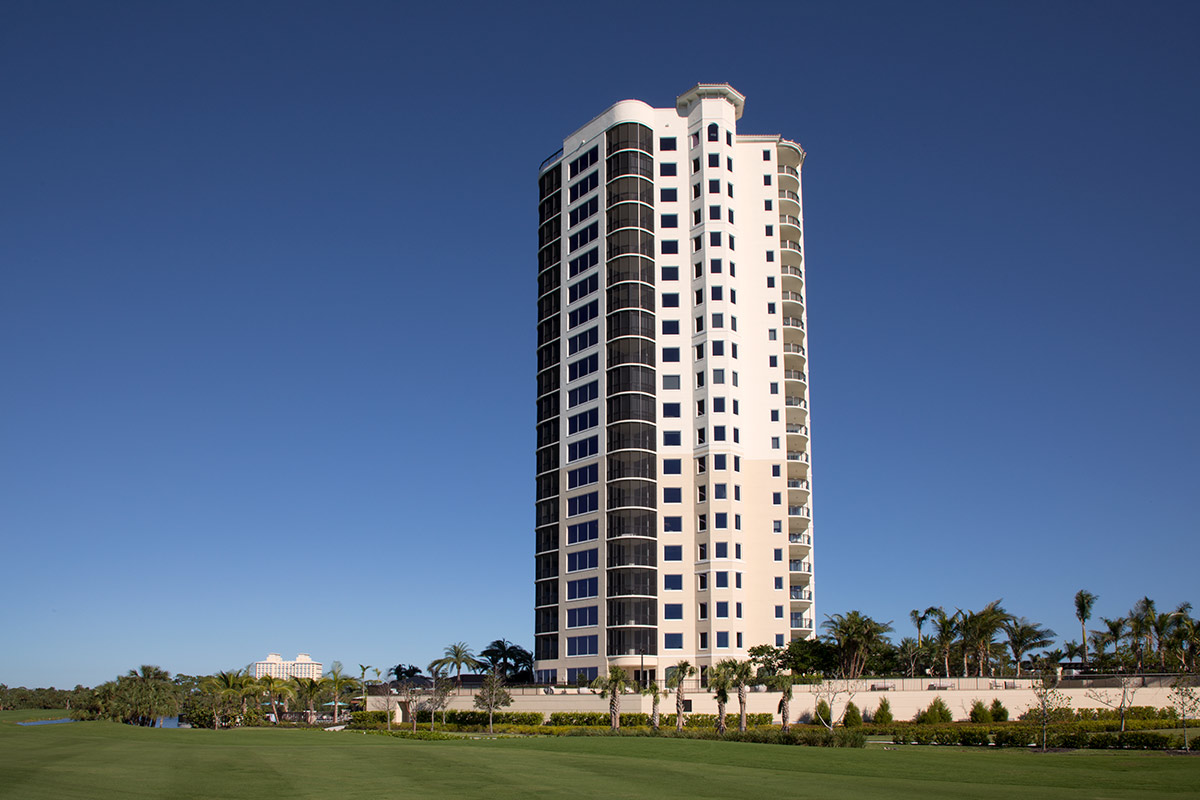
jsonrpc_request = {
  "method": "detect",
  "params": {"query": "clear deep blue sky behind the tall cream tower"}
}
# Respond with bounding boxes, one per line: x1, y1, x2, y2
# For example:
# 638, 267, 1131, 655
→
0, 0, 1200, 686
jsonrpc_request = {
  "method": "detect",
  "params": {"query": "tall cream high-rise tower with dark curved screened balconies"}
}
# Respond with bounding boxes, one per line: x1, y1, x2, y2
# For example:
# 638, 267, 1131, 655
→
534, 84, 814, 682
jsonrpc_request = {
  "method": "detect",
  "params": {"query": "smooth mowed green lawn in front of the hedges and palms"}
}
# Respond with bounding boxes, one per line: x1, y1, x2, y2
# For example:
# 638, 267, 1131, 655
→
0, 711, 1200, 800
